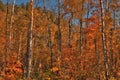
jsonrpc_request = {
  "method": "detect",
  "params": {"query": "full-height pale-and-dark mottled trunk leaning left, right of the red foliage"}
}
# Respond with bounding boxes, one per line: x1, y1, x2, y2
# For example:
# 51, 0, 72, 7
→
100, 0, 108, 80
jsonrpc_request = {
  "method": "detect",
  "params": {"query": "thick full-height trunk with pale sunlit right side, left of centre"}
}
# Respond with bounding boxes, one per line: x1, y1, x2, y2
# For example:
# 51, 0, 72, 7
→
26, 0, 34, 79
